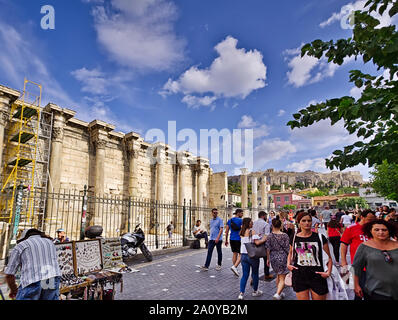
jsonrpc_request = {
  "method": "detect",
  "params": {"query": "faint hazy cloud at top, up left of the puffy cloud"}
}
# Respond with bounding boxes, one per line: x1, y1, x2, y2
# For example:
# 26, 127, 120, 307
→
93, 0, 185, 71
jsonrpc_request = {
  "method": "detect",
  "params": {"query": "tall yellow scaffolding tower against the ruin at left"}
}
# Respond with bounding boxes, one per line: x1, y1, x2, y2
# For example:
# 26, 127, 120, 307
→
0, 79, 42, 223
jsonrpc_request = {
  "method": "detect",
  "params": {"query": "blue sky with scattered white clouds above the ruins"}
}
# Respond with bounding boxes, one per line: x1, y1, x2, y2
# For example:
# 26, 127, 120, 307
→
0, 0, 389, 178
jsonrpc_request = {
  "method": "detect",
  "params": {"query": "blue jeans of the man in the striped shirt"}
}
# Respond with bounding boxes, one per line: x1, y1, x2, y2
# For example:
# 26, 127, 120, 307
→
16, 277, 60, 300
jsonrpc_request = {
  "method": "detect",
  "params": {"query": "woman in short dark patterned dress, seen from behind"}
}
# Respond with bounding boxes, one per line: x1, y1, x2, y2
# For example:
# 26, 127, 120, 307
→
265, 216, 289, 300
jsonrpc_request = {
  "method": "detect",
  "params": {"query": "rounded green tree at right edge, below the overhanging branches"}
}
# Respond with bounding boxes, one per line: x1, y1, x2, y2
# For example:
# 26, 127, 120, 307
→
370, 160, 398, 201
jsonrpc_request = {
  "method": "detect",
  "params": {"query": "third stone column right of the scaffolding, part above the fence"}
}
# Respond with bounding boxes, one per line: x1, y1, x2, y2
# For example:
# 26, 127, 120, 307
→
125, 132, 141, 198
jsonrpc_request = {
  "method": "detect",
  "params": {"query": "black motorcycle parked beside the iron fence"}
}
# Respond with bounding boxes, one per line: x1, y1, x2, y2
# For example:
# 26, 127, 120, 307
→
120, 223, 153, 262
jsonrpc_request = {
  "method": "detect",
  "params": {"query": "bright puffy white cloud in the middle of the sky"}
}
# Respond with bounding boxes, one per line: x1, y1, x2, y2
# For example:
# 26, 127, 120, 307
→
160, 36, 267, 107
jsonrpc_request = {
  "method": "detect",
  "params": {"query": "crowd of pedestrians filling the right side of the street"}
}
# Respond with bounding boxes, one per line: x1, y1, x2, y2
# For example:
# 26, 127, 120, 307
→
202, 206, 398, 300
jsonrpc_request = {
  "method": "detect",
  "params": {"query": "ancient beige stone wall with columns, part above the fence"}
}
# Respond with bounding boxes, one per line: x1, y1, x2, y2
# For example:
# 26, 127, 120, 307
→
0, 85, 228, 235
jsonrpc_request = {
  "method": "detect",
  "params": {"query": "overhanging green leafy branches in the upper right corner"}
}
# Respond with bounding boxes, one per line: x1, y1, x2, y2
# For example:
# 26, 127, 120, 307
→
288, 0, 398, 170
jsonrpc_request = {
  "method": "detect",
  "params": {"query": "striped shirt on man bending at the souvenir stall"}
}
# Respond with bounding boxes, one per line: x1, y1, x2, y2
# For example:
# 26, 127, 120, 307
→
4, 235, 61, 288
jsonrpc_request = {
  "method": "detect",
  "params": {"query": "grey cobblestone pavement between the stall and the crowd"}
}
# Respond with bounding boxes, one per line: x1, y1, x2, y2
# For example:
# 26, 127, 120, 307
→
115, 247, 296, 300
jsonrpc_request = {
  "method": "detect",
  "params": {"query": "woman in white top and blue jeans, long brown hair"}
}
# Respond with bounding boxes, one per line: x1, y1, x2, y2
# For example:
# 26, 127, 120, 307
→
238, 218, 267, 300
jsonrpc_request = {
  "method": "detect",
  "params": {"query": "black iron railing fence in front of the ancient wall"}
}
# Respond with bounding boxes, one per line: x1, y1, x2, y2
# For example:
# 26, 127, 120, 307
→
0, 190, 246, 250
